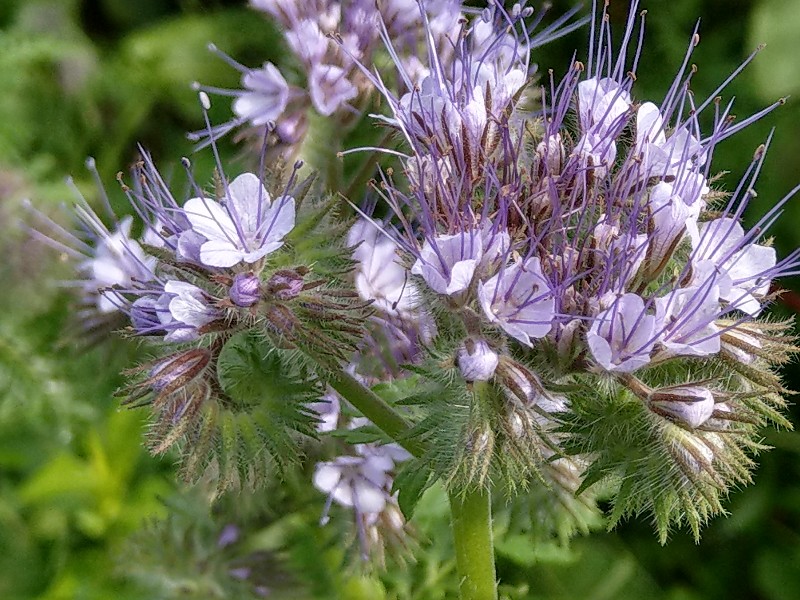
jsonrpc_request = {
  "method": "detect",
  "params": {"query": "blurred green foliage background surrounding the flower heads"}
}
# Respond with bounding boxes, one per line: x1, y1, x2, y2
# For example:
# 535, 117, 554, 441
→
0, 0, 800, 600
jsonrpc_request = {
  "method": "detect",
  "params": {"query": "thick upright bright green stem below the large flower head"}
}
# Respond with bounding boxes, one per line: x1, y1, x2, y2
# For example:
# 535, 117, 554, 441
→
450, 488, 497, 600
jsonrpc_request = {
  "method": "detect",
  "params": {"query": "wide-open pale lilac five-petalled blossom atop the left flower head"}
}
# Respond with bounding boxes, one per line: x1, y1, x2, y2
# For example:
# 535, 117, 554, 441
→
183, 173, 295, 267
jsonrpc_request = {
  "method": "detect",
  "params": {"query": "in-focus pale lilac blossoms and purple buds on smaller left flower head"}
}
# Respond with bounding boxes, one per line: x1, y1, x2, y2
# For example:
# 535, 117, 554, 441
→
122, 156, 302, 342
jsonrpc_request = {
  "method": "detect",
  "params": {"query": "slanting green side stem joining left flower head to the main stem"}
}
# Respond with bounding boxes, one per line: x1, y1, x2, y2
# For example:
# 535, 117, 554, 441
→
328, 371, 424, 456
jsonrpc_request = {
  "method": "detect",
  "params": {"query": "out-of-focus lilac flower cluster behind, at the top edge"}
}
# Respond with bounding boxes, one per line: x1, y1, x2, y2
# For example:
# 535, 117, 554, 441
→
194, 0, 461, 157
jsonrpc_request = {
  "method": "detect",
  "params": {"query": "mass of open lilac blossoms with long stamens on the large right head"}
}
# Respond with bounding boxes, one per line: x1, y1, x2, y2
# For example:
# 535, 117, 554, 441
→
368, 0, 797, 384
